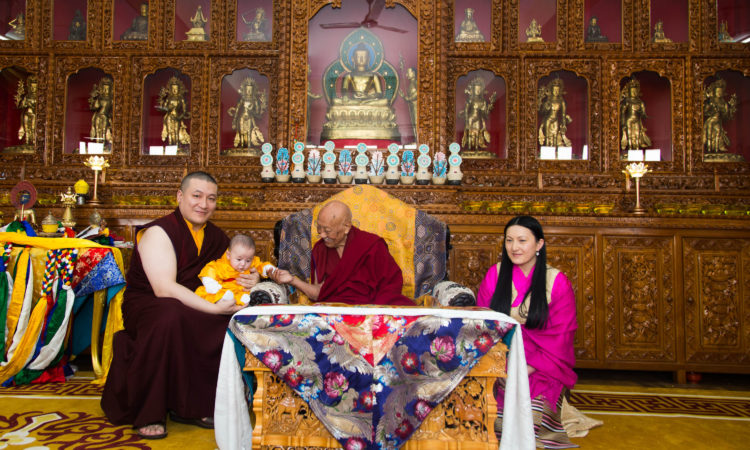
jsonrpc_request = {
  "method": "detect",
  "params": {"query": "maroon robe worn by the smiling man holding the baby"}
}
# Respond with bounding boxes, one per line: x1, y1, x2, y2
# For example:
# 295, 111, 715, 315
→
101, 209, 231, 428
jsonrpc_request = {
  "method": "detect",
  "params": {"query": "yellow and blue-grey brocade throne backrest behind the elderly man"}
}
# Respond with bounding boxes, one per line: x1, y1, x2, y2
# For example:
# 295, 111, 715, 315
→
277, 184, 447, 299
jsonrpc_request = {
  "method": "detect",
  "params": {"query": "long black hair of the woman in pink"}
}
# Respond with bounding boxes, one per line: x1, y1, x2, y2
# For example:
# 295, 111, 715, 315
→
490, 216, 549, 328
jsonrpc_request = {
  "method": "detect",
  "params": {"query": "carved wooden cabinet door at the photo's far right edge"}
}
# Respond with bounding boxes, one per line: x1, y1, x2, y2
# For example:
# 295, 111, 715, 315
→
683, 238, 750, 365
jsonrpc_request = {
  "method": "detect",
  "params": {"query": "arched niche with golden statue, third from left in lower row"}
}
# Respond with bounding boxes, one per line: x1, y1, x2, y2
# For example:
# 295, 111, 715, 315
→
141, 68, 192, 156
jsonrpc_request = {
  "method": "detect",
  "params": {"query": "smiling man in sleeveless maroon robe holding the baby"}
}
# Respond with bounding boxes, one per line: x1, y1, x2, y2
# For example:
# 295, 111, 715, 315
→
101, 172, 259, 439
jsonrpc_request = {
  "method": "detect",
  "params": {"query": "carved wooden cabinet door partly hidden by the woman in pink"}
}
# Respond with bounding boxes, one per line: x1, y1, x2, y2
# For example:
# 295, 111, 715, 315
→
545, 231, 598, 361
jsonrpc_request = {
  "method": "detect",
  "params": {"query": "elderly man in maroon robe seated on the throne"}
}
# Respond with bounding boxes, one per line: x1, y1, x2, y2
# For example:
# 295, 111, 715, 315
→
271, 201, 414, 306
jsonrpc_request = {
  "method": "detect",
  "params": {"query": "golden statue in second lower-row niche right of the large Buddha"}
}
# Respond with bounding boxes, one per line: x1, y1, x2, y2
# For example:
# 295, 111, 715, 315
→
537, 78, 573, 147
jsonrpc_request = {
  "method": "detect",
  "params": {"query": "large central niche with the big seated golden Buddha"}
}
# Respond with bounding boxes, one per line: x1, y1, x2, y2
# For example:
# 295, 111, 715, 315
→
306, 0, 419, 148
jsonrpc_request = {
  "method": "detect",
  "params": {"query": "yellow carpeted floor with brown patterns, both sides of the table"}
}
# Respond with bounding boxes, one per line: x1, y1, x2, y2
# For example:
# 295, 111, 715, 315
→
0, 373, 750, 450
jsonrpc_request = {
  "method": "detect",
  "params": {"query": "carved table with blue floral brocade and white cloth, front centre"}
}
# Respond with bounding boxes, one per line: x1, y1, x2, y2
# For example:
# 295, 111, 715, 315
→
214, 305, 535, 449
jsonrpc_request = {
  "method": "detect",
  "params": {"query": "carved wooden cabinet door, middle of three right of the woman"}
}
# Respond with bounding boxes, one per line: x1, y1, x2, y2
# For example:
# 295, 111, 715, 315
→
603, 236, 676, 363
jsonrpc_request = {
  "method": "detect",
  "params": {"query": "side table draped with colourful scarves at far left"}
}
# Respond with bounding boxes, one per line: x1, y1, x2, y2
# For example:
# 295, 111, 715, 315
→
0, 232, 125, 384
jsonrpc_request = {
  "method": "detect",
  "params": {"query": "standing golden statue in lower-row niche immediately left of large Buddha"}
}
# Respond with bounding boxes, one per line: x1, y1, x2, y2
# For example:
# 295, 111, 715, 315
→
227, 77, 268, 155
